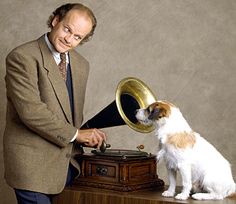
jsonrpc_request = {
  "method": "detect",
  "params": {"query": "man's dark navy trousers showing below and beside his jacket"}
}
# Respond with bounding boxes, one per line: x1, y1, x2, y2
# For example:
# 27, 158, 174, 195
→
14, 164, 78, 204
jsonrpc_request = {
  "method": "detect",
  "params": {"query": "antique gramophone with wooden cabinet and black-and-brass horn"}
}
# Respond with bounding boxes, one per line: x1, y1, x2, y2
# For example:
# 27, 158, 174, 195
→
74, 77, 164, 192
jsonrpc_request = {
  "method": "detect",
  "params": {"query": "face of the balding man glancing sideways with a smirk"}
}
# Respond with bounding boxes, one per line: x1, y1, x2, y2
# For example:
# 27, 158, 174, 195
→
49, 9, 92, 53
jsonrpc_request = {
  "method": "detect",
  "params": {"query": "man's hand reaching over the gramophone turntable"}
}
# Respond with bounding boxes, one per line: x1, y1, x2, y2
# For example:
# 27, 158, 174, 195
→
76, 128, 106, 149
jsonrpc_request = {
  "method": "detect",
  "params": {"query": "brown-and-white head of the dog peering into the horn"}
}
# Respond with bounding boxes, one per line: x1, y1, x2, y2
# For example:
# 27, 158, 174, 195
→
135, 101, 175, 125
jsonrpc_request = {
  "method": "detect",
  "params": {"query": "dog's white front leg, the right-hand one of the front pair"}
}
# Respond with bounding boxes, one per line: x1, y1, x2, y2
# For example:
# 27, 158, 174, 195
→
175, 164, 192, 200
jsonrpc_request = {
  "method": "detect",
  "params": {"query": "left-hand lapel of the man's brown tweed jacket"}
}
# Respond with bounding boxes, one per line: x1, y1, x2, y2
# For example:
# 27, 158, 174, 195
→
38, 35, 73, 123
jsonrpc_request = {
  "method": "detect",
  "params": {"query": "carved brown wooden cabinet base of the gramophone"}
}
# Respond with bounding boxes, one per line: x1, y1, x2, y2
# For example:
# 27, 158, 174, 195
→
74, 149, 164, 192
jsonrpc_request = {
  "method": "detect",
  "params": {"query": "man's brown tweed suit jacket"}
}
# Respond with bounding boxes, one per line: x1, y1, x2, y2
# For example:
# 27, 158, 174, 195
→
3, 36, 89, 194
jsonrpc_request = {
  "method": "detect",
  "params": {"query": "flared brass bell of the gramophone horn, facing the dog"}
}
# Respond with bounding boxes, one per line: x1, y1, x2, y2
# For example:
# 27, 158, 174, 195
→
115, 77, 157, 133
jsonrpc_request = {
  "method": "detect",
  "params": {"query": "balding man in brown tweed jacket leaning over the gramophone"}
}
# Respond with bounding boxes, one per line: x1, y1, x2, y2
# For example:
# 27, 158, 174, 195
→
4, 4, 106, 204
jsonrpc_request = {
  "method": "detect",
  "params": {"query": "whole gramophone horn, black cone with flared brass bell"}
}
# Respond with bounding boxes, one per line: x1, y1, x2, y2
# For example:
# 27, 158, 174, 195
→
81, 77, 157, 133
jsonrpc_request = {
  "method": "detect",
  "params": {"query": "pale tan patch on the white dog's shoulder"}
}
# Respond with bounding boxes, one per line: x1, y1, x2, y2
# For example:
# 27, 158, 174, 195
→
167, 131, 196, 149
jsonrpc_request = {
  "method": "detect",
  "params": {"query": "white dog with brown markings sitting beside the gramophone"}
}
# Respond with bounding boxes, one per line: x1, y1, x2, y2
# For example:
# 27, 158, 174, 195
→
136, 101, 236, 200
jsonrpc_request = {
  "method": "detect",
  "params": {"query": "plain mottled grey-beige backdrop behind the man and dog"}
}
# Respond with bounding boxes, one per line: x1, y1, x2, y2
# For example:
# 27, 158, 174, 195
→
0, 0, 236, 204
